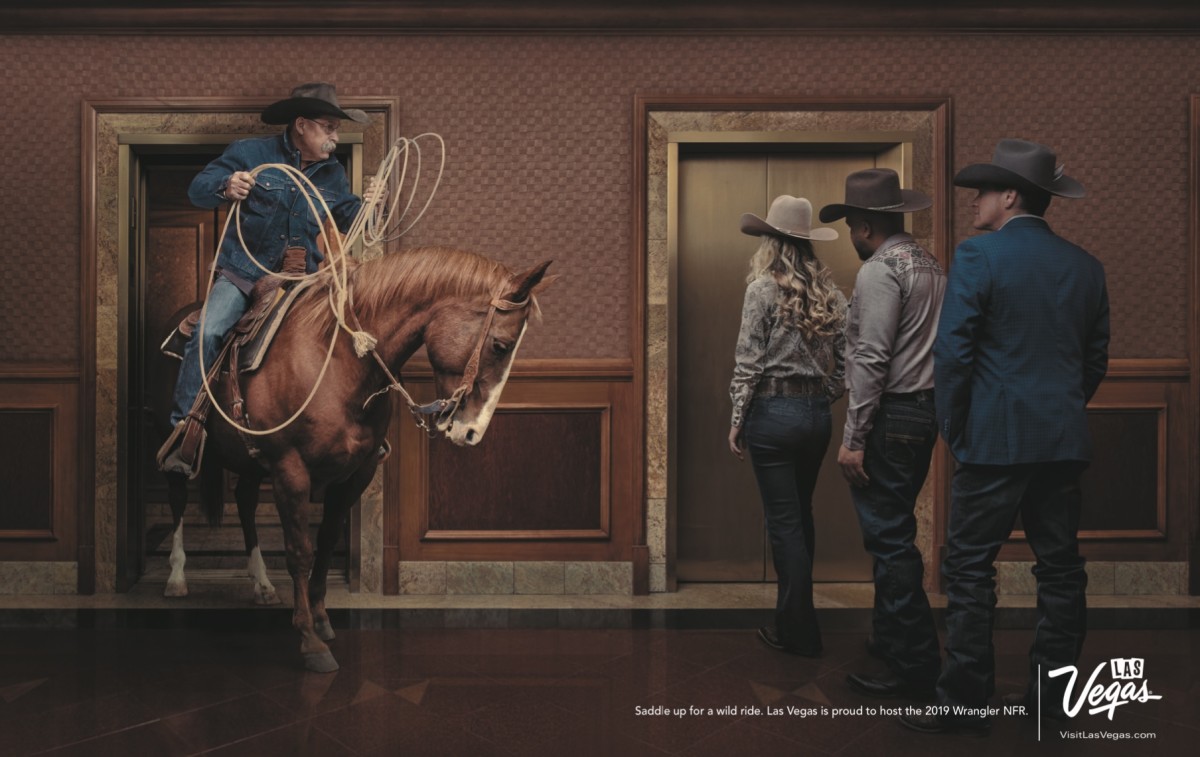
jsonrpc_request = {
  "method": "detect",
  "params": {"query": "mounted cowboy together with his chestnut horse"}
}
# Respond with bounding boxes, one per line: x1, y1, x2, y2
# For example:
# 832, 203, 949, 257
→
152, 84, 557, 673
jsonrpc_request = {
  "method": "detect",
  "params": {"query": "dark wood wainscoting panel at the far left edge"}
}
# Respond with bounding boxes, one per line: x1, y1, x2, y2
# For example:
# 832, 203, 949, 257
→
0, 380, 79, 560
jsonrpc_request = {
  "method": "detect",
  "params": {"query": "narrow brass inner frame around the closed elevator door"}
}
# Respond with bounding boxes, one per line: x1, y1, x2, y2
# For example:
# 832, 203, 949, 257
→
666, 131, 916, 588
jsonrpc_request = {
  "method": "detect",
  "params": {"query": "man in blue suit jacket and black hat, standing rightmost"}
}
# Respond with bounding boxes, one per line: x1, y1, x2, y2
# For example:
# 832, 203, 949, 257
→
902, 139, 1109, 732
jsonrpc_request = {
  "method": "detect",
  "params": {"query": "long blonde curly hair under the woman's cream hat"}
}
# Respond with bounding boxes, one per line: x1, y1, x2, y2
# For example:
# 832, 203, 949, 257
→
746, 234, 846, 342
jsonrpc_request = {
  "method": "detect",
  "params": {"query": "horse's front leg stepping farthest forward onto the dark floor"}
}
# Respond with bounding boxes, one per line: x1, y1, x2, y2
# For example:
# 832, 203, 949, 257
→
271, 451, 337, 673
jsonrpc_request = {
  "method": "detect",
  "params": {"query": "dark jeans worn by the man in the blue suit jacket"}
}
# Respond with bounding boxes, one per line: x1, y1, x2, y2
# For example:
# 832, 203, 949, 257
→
937, 462, 1087, 714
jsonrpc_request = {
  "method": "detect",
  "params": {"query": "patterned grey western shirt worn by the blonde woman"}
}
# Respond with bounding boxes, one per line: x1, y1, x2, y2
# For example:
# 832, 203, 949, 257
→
730, 274, 846, 428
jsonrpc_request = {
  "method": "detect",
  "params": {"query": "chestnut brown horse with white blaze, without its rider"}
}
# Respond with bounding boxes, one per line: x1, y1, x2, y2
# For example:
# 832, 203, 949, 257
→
167, 247, 557, 672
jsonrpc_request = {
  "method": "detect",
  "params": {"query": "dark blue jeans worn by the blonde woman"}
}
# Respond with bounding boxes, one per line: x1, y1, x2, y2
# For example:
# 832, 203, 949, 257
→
744, 395, 833, 650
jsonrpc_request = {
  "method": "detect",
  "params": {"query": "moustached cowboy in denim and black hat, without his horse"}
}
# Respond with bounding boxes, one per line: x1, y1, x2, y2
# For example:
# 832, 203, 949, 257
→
161, 82, 386, 476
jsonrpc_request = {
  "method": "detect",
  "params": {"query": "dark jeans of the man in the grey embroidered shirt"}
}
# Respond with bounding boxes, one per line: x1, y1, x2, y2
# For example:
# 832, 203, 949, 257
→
850, 391, 942, 686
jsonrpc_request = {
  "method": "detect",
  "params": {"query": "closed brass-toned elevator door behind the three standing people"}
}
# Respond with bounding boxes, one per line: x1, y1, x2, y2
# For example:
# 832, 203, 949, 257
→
674, 145, 900, 582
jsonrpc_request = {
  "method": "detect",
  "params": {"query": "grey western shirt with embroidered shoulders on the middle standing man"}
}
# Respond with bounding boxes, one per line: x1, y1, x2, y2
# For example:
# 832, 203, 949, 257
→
842, 234, 946, 450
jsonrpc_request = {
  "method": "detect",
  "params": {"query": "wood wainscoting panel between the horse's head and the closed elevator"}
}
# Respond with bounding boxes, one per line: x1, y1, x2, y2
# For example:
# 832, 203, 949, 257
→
383, 361, 642, 594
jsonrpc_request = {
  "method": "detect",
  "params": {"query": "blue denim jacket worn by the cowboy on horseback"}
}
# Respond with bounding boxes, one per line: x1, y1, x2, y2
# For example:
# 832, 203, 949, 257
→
187, 131, 362, 283
